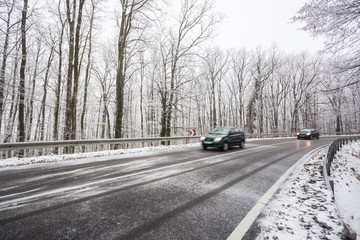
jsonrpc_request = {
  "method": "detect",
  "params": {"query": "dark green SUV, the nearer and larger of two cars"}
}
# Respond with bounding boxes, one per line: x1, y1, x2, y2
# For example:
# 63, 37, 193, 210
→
200, 127, 245, 151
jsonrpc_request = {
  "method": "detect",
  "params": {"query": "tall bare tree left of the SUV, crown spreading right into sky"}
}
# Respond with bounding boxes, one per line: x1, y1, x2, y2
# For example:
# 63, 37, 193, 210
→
159, 0, 219, 137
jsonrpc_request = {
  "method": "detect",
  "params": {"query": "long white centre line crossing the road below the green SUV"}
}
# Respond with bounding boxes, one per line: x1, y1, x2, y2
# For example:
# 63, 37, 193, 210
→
0, 142, 288, 207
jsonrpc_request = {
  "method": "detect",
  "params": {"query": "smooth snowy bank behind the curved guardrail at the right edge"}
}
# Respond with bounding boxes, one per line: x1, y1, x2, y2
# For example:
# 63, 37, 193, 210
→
330, 141, 360, 239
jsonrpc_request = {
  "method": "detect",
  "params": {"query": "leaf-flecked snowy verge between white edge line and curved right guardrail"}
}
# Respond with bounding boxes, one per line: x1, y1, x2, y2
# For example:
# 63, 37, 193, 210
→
257, 148, 343, 239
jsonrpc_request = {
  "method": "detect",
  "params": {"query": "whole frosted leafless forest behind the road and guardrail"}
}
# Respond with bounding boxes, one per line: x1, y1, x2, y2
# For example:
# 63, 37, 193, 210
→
0, 0, 360, 142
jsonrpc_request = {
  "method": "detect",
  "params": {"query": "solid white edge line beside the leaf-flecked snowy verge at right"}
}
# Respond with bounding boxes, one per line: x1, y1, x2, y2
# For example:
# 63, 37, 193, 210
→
227, 145, 326, 240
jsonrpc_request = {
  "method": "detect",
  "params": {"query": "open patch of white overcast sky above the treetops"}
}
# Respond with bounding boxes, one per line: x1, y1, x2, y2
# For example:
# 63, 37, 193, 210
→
214, 0, 323, 53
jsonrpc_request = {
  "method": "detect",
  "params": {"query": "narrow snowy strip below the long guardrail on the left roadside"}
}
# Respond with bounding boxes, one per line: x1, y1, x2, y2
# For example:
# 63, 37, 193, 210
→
0, 143, 199, 168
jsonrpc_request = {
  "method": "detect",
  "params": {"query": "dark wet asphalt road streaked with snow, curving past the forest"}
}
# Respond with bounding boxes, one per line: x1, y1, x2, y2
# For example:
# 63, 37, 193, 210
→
0, 137, 340, 239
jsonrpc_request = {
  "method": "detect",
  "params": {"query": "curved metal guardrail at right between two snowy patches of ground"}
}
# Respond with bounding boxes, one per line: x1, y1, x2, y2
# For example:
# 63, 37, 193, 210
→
323, 136, 360, 239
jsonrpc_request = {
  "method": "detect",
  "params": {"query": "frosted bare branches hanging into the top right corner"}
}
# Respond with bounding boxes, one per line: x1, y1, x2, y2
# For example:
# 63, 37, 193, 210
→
293, 0, 360, 86
